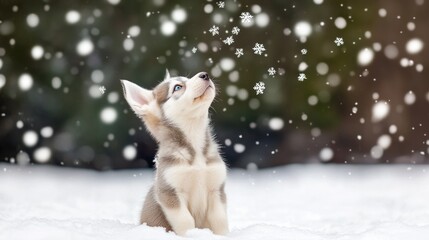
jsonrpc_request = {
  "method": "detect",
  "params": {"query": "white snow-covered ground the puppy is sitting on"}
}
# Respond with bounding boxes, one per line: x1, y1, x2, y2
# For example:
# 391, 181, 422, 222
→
0, 165, 429, 240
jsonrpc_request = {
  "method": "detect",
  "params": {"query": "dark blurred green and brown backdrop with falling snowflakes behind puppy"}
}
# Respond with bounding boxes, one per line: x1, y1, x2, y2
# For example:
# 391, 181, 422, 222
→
0, 0, 429, 170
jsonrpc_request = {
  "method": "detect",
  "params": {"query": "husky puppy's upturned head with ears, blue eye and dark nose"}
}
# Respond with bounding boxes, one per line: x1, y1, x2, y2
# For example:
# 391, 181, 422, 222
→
121, 71, 216, 137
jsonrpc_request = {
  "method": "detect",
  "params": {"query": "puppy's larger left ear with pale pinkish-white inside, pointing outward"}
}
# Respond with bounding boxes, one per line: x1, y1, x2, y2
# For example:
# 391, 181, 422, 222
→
121, 80, 155, 116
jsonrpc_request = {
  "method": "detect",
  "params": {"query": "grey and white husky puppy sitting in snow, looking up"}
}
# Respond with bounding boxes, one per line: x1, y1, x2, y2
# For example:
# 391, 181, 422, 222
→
121, 71, 228, 235
